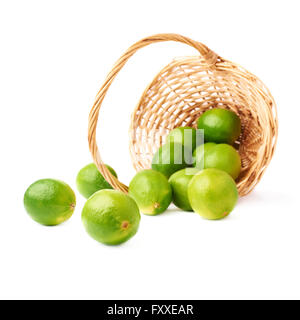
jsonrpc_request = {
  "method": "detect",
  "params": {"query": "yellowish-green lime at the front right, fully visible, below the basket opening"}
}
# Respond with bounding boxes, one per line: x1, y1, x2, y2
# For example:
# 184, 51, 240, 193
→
188, 169, 238, 220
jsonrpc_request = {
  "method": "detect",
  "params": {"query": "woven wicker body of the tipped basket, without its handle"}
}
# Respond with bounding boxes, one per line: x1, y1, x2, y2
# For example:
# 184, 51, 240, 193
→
131, 57, 275, 196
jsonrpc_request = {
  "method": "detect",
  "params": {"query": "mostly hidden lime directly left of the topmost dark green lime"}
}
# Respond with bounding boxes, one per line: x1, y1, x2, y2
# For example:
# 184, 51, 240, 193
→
167, 127, 200, 151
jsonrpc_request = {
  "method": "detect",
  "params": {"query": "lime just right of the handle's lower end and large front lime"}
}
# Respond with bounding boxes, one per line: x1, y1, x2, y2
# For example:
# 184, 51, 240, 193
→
129, 169, 172, 216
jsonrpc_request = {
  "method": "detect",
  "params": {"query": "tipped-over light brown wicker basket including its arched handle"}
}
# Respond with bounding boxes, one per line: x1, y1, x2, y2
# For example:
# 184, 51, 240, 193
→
89, 34, 278, 196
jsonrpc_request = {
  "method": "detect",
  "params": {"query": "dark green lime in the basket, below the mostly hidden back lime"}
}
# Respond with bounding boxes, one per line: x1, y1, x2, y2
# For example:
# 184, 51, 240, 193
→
152, 142, 193, 178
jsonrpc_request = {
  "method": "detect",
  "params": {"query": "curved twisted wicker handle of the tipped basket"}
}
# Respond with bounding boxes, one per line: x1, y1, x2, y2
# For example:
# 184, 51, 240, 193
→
88, 33, 218, 193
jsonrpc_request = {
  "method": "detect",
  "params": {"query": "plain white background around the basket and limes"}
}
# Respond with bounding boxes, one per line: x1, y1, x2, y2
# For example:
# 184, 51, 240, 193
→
0, 0, 300, 299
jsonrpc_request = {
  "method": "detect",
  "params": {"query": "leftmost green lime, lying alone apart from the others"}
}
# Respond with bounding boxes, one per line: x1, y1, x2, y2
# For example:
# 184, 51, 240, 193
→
24, 179, 76, 226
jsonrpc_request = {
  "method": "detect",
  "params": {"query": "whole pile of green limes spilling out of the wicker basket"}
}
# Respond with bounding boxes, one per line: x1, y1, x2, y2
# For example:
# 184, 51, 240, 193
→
24, 109, 241, 245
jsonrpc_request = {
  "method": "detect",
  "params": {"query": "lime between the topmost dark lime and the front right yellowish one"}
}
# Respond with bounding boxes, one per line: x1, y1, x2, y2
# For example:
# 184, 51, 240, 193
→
204, 143, 241, 179
